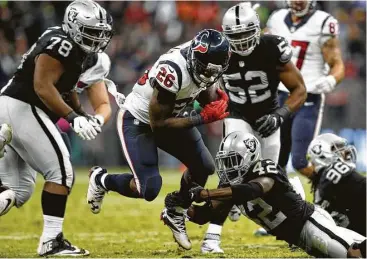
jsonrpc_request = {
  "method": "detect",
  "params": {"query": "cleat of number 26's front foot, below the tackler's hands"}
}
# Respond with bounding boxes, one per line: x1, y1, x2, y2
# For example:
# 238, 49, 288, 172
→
161, 207, 191, 250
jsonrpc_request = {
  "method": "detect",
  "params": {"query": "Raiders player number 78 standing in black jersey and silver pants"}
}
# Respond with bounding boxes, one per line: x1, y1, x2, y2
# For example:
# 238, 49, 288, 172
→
0, 0, 112, 256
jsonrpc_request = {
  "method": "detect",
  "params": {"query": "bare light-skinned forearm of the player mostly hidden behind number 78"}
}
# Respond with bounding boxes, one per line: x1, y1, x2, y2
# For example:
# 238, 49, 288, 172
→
86, 81, 112, 125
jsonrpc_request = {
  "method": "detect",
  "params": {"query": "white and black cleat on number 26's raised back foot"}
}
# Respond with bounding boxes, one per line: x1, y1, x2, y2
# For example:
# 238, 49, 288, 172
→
87, 166, 107, 214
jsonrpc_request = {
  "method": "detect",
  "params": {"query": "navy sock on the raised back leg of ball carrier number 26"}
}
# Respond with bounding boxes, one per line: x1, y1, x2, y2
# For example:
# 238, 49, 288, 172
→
100, 174, 140, 198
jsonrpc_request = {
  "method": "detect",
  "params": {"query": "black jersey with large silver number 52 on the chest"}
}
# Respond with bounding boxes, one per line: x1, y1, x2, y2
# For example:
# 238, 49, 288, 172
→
223, 35, 292, 124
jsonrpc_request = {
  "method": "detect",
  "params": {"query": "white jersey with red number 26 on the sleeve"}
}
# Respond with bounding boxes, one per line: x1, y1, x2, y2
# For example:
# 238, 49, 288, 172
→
124, 41, 206, 124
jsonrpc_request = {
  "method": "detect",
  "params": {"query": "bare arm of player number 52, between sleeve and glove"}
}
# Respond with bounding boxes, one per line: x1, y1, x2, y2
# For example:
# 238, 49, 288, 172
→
279, 61, 307, 113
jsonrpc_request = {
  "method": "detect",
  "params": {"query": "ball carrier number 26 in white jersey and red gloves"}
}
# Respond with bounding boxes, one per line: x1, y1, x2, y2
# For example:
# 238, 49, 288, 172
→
87, 29, 230, 249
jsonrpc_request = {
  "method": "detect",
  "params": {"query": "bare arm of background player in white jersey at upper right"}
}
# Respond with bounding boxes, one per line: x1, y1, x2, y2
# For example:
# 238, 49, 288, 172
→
321, 37, 345, 84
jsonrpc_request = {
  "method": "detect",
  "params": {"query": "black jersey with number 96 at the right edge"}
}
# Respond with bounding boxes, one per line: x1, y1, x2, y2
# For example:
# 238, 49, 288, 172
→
314, 161, 366, 236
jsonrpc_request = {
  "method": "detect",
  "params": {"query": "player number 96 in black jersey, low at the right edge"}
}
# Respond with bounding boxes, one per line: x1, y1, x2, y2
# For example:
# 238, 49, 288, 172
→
307, 133, 366, 236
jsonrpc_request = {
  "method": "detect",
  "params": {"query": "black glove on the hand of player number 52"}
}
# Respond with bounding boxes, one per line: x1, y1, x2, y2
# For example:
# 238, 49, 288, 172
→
255, 105, 291, 138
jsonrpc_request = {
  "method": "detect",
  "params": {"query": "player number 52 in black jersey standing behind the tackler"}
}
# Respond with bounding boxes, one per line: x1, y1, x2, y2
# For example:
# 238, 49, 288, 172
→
201, 3, 307, 253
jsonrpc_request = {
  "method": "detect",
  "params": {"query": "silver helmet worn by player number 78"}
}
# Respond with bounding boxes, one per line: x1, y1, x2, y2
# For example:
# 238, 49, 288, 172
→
62, 0, 112, 53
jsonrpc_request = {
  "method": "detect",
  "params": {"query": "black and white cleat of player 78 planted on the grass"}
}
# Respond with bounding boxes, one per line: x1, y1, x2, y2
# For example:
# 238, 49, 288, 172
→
37, 233, 89, 256
